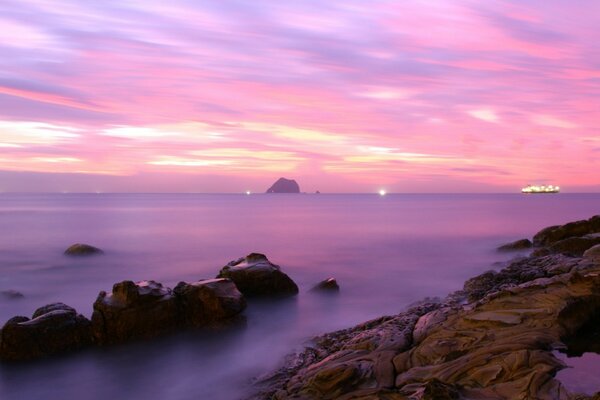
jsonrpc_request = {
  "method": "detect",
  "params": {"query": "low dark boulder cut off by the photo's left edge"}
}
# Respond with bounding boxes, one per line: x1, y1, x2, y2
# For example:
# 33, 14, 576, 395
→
0, 303, 92, 361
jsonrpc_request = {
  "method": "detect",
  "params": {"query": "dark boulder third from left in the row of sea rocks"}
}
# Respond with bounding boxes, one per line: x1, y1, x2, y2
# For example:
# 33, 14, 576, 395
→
173, 279, 246, 327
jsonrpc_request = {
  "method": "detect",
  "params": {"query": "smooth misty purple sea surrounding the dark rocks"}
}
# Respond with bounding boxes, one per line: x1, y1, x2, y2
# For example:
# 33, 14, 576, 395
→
0, 193, 600, 400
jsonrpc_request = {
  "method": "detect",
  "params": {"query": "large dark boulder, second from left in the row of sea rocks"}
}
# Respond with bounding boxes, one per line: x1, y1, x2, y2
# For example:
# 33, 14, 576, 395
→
92, 281, 181, 345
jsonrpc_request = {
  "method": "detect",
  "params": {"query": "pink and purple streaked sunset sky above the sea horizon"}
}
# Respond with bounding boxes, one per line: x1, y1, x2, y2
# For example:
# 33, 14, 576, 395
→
0, 0, 600, 193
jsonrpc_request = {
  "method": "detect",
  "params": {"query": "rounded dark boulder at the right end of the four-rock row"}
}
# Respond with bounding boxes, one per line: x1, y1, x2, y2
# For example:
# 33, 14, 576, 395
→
217, 253, 298, 296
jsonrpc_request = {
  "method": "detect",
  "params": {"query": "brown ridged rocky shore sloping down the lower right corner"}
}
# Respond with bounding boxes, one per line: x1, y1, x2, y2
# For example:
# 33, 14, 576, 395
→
252, 216, 600, 400
